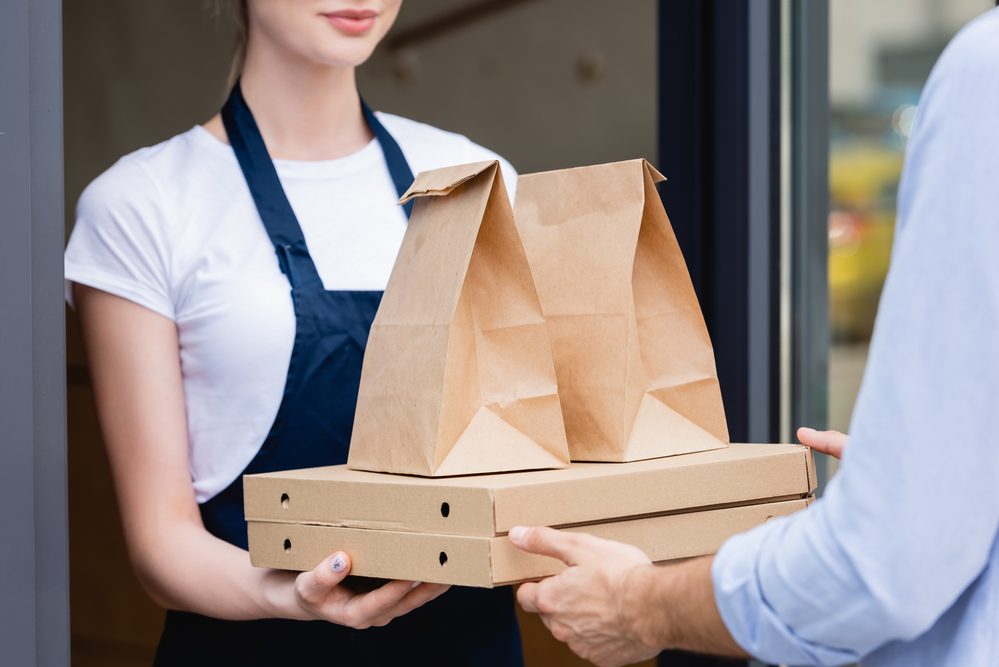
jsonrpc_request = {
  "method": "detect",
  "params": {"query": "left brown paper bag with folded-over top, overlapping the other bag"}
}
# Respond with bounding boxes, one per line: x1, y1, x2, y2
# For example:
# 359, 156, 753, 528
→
347, 161, 569, 477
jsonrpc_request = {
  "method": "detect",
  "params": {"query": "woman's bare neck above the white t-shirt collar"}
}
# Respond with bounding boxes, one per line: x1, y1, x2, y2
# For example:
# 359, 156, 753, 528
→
205, 38, 372, 160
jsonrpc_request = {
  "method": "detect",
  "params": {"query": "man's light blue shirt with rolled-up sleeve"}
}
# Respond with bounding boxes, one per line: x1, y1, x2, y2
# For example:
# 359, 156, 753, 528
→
713, 10, 999, 667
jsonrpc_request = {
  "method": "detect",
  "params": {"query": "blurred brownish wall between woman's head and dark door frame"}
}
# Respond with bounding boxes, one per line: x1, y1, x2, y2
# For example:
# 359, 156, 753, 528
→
359, 0, 657, 172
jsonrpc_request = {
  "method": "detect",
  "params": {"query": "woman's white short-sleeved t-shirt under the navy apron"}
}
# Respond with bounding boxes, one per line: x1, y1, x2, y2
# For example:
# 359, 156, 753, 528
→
65, 113, 516, 502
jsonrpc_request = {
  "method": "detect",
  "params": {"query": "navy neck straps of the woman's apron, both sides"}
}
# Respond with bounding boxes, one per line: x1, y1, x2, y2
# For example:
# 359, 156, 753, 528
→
222, 81, 413, 288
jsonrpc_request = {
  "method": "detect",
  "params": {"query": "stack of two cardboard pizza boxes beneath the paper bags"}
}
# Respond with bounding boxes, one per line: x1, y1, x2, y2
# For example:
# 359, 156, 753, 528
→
244, 445, 815, 587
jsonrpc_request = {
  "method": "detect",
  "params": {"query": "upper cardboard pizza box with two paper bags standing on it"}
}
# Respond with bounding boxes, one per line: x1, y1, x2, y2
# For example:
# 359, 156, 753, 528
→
243, 444, 815, 537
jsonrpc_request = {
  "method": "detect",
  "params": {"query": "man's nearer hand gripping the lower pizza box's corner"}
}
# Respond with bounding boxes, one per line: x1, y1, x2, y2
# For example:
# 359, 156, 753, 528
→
510, 527, 663, 665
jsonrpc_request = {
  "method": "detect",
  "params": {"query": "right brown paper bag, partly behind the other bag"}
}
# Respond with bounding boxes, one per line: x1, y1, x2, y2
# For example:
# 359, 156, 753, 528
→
515, 160, 728, 461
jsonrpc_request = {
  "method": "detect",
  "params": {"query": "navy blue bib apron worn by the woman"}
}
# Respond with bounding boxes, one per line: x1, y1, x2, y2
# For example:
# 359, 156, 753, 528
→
155, 83, 523, 667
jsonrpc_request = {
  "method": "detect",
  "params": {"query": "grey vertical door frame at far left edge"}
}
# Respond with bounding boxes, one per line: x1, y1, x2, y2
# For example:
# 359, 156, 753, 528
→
0, 0, 69, 665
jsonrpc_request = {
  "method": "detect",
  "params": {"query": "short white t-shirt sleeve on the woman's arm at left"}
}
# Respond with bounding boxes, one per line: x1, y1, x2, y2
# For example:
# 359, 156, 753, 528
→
65, 157, 175, 319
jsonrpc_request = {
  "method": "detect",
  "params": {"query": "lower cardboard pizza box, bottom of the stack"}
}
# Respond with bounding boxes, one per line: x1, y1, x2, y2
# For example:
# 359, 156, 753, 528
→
248, 498, 809, 588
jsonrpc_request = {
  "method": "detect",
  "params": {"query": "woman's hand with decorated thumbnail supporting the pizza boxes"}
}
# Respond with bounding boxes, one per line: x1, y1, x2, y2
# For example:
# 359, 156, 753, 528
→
295, 551, 449, 630
